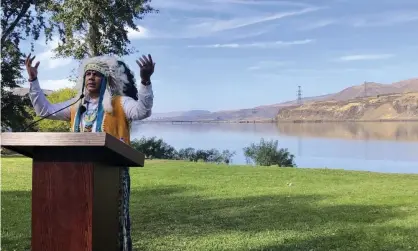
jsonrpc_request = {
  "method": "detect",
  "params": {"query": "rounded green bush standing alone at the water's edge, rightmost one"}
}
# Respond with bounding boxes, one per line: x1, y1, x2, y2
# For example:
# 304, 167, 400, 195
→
243, 138, 296, 167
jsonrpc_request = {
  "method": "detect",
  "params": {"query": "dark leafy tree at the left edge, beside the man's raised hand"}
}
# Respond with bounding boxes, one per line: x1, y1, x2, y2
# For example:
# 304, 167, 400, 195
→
1, 0, 51, 131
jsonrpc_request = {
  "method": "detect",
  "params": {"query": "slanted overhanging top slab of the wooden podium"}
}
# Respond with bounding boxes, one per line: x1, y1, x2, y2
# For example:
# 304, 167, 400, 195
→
1, 132, 145, 167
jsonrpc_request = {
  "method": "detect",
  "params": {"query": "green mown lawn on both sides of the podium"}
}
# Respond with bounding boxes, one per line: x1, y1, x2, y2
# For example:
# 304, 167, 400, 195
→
1, 158, 418, 251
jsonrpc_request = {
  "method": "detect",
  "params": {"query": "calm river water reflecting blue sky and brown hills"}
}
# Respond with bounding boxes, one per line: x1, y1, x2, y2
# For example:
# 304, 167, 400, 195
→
132, 122, 418, 173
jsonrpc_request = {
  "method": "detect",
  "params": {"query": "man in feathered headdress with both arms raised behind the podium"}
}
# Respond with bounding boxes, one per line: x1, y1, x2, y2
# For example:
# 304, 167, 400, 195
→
25, 54, 155, 251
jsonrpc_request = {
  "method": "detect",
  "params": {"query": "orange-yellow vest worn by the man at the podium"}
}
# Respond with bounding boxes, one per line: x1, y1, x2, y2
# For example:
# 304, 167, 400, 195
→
71, 96, 131, 145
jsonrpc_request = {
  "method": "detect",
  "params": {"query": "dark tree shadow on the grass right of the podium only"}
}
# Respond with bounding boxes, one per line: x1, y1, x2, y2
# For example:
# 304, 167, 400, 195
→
131, 186, 417, 250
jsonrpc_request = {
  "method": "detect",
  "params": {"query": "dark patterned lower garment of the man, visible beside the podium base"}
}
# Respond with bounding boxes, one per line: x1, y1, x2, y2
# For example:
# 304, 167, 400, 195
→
119, 167, 132, 251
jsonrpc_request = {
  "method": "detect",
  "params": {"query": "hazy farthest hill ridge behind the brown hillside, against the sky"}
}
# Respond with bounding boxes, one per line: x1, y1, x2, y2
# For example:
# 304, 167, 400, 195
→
145, 78, 418, 121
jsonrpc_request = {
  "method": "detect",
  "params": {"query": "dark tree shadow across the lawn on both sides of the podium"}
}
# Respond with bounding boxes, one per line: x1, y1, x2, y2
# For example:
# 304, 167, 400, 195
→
1, 186, 418, 251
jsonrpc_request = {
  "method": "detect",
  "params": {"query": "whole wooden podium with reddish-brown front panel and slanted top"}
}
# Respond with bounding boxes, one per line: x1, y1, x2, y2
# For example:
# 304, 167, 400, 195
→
1, 132, 144, 251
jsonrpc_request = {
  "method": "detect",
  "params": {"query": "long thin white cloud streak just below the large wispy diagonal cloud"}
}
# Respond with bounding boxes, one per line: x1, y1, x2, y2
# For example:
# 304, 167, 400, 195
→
188, 39, 315, 49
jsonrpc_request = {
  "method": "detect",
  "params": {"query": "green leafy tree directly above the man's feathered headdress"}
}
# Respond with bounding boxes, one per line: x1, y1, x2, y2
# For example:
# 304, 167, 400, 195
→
51, 0, 158, 60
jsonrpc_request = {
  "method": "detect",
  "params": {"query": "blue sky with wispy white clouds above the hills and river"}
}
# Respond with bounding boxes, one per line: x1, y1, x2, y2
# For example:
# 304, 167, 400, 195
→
22, 0, 418, 113
